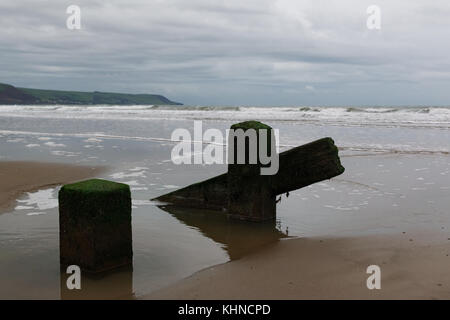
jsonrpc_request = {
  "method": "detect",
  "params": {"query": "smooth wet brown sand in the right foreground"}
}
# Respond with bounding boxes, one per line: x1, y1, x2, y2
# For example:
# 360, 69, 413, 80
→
144, 232, 450, 300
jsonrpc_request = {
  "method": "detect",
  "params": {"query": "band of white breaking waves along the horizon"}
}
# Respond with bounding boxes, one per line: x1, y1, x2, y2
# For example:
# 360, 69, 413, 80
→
0, 105, 450, 130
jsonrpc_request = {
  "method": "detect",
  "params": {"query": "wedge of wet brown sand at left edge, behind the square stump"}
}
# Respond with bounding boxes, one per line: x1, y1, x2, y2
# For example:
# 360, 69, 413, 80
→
0, 161, 105, 212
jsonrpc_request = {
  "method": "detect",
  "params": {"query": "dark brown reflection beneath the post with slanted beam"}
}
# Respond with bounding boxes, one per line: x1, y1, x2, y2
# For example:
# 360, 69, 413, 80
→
158, 205, 287, 260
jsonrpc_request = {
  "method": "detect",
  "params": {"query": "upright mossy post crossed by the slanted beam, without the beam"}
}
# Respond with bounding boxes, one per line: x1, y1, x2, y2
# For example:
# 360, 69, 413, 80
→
228, 121, 276, 221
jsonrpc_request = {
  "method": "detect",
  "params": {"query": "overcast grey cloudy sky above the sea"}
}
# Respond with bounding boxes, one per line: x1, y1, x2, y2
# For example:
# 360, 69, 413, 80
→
0, 0, 450, 106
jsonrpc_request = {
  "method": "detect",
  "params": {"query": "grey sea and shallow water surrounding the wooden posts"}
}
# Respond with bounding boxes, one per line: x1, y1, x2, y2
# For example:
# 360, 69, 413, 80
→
0, 106, 450, 299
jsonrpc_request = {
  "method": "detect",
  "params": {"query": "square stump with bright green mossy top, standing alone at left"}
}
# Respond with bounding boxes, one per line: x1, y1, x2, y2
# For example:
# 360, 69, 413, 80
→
58, 179, 133, 273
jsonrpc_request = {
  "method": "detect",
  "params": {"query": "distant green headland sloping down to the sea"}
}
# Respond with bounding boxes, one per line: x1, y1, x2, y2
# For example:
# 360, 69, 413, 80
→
0, 83, 182, 105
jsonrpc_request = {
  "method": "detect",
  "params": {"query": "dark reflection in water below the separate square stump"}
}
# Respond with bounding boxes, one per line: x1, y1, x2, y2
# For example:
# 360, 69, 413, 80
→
60, 266, 135, 300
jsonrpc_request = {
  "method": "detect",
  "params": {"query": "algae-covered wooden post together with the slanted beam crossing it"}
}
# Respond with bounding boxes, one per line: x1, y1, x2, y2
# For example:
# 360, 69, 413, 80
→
153, 121, 345, 221
